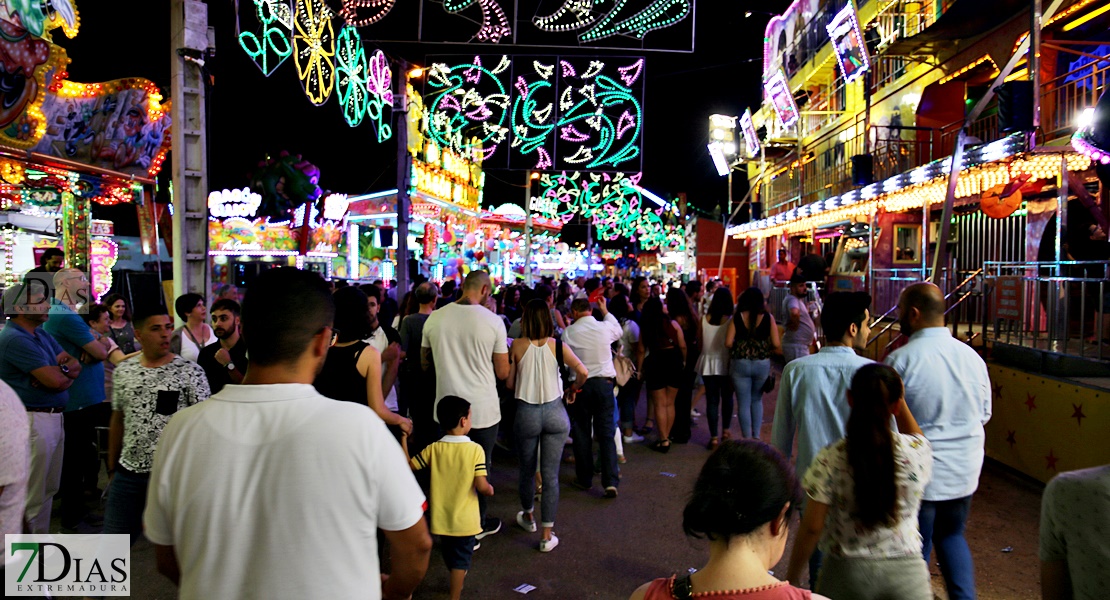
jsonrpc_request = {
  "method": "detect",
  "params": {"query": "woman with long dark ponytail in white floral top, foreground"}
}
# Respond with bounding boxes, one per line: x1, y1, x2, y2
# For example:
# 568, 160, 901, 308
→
786, 363, 932, 600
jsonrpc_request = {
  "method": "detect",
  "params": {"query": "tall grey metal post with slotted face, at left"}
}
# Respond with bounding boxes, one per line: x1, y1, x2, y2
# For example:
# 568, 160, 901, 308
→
168, 0, 211, 302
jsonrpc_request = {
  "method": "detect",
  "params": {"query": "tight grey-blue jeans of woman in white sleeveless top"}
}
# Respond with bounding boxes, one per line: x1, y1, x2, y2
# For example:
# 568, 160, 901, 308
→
513, 400, 571, 527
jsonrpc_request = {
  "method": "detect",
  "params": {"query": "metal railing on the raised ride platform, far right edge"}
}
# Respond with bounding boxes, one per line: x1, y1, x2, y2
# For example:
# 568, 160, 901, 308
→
983, 261, 1110, 360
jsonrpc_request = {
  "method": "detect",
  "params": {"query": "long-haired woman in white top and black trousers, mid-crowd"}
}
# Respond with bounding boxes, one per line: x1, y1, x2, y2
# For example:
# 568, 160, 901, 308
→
695, 286, 733, 450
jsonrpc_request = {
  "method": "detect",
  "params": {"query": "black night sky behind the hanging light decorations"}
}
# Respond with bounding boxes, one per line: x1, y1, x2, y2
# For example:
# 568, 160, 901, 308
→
56, 0, 787, 235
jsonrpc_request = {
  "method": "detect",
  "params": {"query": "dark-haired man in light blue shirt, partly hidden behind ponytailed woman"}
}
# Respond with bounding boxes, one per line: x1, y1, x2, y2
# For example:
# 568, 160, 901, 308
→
771, 292, 871, 587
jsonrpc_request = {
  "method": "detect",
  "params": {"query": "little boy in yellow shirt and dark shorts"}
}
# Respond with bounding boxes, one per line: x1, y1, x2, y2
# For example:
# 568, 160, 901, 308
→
401, 396, 493, 600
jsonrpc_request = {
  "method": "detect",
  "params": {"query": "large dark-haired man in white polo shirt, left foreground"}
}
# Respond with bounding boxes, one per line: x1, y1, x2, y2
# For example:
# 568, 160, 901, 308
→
143, 267, 432, 600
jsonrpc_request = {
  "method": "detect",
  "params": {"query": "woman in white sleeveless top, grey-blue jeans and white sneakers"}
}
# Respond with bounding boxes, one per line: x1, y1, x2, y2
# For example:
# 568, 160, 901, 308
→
506, 299, 589, 552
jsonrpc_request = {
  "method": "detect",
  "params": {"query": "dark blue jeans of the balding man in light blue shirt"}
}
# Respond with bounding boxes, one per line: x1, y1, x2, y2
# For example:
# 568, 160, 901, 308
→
918, 496, 976, 600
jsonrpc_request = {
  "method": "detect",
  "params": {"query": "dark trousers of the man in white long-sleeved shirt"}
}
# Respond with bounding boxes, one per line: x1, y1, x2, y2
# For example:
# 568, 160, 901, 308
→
569, 377, 620, 488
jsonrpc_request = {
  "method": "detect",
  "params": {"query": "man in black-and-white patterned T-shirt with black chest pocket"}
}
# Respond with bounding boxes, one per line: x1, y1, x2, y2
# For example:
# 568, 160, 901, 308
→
103, 307, 210, 543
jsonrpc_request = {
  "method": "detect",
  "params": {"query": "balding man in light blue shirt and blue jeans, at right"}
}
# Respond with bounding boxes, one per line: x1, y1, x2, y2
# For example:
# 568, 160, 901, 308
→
886, 283, 991, 600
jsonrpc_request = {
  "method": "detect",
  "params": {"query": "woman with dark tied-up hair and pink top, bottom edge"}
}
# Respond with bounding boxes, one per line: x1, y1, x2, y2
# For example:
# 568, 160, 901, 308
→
630, 439, 828, 600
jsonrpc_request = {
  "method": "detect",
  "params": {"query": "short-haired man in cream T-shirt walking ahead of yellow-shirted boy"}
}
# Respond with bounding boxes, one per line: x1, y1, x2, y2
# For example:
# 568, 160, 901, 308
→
421, 271, 512, 540
